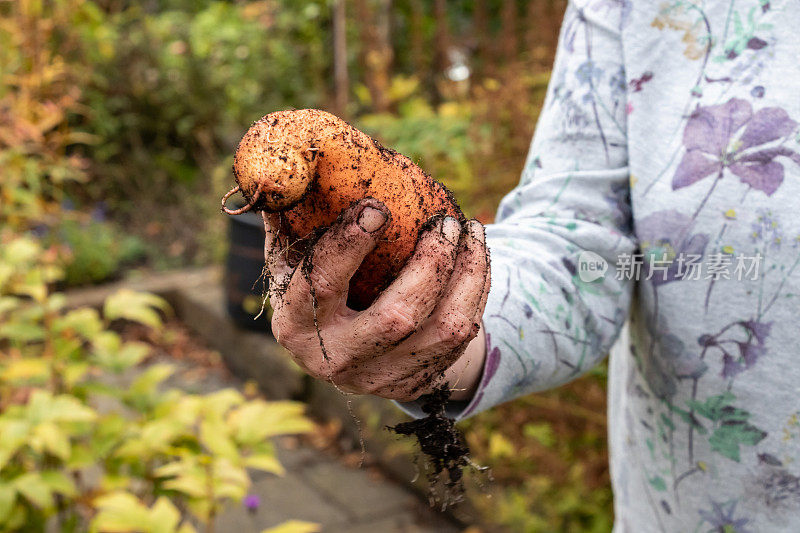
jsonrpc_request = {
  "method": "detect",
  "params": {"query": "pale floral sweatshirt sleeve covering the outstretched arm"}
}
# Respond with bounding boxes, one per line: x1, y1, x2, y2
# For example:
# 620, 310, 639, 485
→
403, 0, 635, 418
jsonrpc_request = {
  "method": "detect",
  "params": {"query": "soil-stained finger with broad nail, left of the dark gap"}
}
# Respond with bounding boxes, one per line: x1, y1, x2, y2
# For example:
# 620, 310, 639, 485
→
284, 198, 390, 323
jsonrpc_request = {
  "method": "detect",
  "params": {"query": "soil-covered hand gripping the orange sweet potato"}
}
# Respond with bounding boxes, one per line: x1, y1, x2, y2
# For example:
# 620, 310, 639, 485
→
263, 199, 490, 401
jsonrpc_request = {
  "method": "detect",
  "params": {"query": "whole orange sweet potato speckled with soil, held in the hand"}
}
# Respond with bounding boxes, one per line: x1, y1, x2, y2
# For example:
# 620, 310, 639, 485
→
222, 109, 464, 309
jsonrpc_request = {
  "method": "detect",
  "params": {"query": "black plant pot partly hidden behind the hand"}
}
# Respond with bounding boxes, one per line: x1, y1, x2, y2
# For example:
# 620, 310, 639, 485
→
225, 208, 272, 334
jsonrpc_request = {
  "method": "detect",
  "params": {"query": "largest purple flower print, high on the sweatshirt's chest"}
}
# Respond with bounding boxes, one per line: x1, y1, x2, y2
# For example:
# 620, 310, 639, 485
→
672, 98, 800, 196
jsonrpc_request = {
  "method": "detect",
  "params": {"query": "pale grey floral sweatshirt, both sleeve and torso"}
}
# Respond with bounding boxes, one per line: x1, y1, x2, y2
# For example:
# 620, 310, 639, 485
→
406, 0, 800, 533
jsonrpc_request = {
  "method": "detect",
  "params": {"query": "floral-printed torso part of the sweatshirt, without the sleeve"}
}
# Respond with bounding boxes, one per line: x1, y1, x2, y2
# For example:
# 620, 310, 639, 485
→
612, 0, 800, 532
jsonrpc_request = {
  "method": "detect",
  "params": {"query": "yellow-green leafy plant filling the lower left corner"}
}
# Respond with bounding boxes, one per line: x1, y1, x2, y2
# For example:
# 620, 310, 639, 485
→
0, 235, 312, 532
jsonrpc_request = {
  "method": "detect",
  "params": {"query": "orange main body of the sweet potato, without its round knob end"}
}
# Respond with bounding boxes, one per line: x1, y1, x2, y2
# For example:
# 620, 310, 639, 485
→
235, 109, 464, 309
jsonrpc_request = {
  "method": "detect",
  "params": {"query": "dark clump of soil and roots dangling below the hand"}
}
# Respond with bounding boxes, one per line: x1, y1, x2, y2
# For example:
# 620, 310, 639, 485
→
388, 383, 471, 506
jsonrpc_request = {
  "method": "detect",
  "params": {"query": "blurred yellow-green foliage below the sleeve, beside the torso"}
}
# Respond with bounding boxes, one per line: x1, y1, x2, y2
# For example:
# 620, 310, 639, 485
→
456, 367, 614, 533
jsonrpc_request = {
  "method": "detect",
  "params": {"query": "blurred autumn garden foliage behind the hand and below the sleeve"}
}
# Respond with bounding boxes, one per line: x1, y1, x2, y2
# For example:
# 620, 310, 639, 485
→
0, 0, 611, 531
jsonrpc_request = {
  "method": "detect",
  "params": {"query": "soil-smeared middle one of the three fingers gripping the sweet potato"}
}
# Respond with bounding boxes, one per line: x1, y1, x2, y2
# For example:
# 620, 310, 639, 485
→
353, 217, 461, 353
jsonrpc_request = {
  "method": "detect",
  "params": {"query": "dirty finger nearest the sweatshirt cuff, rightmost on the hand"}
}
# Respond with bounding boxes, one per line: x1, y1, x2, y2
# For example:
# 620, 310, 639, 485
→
409, 220, 490, 356
